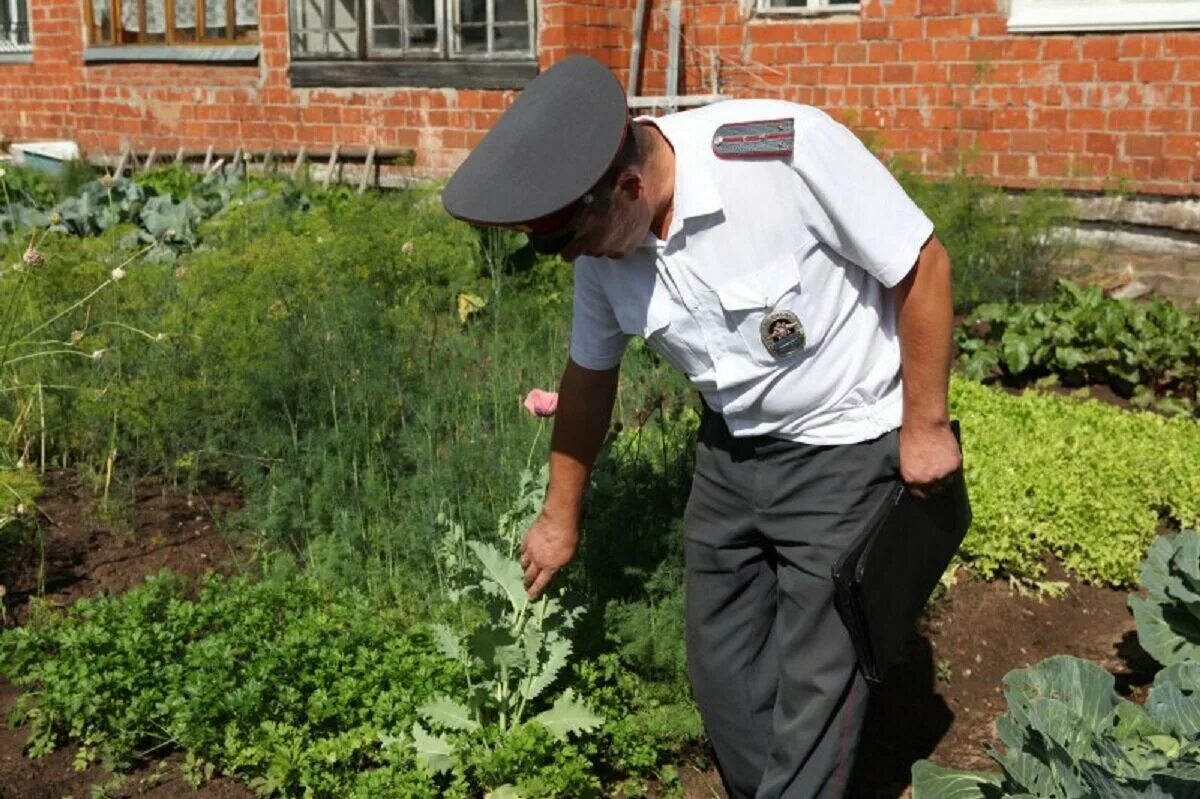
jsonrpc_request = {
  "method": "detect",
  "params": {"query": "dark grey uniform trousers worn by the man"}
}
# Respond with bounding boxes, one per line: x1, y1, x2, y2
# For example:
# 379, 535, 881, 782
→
684, 411, 900, 799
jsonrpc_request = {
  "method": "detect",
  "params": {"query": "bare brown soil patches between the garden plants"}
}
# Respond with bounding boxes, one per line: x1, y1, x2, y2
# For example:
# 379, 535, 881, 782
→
0, 474, 1153, 799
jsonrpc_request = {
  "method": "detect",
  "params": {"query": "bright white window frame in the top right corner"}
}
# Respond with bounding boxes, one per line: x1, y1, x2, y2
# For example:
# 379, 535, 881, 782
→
1008, 0, 1200, 34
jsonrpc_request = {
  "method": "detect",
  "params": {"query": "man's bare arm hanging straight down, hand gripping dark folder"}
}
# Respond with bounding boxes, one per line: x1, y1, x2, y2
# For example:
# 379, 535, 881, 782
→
892, 231, 962, 495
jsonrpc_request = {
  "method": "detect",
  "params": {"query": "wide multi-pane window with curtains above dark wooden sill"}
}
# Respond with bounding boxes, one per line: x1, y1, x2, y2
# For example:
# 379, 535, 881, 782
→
289, 0, 534, 60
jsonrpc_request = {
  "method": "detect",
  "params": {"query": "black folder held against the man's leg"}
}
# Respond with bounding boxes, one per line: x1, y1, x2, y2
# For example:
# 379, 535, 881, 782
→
833, 422, 971, 683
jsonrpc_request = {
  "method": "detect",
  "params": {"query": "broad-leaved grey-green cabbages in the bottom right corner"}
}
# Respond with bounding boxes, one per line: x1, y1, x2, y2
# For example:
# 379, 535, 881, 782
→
912, 531, 1200, 799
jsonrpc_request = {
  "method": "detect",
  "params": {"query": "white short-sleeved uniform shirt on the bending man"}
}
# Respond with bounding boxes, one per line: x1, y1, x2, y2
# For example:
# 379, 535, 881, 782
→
571, 100, 934, 444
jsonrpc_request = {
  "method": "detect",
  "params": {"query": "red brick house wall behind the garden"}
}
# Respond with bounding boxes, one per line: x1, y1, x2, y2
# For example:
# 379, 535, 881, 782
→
0, 0, 1200, 196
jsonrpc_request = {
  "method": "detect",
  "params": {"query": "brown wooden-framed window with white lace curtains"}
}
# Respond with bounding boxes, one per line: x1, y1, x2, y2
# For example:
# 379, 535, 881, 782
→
86, 0, 258, 46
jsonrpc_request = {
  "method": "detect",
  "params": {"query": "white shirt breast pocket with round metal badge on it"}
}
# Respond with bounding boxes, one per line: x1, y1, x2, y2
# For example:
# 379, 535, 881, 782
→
713, 248, 827, 366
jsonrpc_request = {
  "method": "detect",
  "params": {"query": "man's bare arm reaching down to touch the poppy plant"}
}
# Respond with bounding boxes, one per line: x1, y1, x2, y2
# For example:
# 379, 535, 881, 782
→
521, 360, 618, 599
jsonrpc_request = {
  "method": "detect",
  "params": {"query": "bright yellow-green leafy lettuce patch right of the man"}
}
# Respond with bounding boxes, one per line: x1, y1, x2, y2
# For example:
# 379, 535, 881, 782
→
950, 378, 1200, 585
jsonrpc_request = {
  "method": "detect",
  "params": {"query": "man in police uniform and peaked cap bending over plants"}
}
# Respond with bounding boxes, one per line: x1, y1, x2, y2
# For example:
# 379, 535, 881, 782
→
443, 56, 960, 799
